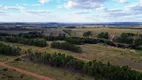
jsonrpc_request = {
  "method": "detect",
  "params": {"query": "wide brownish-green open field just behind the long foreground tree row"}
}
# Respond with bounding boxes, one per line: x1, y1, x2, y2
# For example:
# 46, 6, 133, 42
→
4, 41, 142, 70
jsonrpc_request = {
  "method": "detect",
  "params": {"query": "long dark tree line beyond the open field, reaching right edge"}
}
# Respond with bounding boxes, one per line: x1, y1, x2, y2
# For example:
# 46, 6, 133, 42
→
66, 34, 142, 50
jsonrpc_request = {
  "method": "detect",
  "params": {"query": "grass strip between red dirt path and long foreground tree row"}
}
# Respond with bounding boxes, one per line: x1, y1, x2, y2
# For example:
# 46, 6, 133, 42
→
8, 61, 95, 80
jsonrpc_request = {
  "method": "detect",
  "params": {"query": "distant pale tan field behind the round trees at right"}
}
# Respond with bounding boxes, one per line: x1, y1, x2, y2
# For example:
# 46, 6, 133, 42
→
71, 28, 142, 36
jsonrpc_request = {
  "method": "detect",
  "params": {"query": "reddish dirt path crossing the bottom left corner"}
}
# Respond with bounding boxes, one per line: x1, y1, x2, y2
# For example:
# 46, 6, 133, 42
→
0, 62, 54, 80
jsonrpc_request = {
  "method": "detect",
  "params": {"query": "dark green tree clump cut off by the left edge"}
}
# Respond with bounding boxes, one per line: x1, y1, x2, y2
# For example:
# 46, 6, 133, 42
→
0, 42, 21, 56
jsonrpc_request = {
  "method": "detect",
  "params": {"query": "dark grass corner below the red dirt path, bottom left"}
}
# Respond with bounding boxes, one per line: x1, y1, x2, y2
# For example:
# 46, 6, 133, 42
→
0, 67, 39, 80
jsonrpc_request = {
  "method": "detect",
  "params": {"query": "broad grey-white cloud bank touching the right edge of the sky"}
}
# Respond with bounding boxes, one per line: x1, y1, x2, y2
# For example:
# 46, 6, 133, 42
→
96, 2, 142, 18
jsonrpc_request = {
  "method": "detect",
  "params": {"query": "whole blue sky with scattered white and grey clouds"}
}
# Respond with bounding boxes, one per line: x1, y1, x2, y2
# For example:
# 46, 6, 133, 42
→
0, 0, 142, 23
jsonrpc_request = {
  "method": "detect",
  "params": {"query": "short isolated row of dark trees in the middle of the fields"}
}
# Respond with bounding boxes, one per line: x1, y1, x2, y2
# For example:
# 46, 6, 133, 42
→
51, 42, 82, 53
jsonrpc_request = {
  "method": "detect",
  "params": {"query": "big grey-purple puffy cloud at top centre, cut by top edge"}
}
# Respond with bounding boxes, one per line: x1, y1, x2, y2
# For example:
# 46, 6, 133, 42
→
65, 0, 107, 9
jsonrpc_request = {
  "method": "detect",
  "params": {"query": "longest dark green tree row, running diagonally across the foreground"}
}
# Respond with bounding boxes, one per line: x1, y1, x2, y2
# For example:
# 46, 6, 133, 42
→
28, 51, 142, 80
